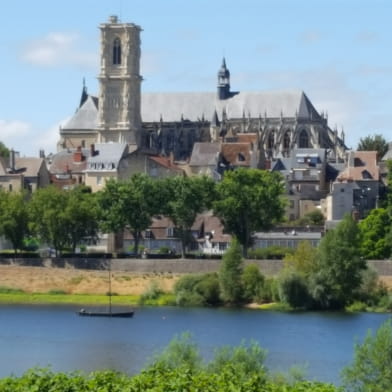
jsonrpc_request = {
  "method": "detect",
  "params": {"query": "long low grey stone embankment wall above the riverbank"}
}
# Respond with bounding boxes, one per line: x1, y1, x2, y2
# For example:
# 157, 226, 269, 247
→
0, 258, 392, 276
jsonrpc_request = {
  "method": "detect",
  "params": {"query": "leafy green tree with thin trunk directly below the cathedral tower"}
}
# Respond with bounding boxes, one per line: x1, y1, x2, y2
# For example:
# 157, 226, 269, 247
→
97, 174, 160, 253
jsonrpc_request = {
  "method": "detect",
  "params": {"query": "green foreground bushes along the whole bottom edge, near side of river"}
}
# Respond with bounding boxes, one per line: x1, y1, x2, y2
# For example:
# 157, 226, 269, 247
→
0, 321, 392, 392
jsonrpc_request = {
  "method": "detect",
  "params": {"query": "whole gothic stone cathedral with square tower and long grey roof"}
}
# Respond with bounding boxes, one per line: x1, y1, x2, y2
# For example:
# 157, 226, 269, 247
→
58, 16, 346, 161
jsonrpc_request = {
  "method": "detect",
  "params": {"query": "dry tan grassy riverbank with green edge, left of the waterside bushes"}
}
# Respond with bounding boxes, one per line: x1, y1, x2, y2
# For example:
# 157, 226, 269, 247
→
0, 265, 180, 305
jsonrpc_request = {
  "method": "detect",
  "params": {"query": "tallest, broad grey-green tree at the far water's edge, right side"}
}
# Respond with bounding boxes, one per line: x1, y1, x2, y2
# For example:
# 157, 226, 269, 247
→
311, 214, 367, 308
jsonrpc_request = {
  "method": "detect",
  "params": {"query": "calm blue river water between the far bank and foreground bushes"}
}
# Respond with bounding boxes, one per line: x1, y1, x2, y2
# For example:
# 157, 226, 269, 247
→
0, 306, 391, 383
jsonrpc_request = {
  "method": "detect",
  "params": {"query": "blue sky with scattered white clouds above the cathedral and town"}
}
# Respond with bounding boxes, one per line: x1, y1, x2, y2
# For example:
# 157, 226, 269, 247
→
0, 0, 392, 156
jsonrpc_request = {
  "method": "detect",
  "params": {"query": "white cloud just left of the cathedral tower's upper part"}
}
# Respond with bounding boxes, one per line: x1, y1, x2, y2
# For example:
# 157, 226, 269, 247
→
21, 32, 98, 68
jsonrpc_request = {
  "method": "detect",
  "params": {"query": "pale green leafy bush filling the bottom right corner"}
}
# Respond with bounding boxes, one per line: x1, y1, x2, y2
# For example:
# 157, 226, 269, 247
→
342, 320, 392, 392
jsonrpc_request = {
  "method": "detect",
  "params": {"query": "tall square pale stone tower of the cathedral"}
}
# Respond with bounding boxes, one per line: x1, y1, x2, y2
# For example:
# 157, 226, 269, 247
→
98, 16, 142, 144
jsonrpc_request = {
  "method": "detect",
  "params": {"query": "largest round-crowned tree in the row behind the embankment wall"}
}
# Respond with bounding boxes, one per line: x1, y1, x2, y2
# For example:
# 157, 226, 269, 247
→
214, 168, 285, 256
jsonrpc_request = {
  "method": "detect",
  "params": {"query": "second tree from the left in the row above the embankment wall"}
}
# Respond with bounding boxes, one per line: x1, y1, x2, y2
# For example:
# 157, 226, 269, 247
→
29, 186, 69, 256
